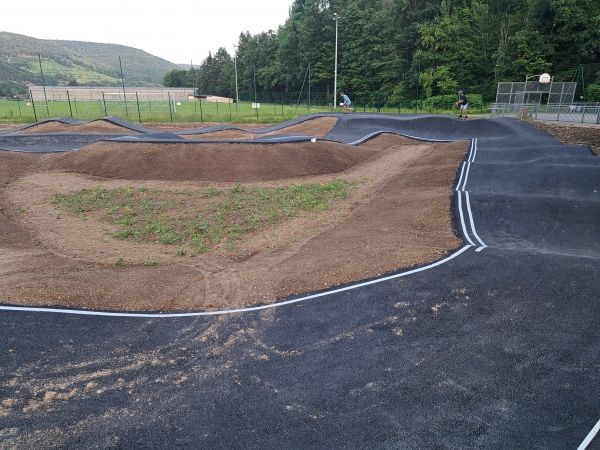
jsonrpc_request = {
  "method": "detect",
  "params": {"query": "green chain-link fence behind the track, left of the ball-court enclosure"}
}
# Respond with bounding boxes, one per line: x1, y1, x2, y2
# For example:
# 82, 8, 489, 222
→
0, 86, 472, 123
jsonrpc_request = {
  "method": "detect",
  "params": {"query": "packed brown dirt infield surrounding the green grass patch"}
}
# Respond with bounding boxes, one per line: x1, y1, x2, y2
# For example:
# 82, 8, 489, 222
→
0, 118, 592, 311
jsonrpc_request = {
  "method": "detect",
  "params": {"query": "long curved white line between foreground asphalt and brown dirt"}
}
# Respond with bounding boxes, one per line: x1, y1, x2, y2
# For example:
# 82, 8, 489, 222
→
0, 245, 473, 318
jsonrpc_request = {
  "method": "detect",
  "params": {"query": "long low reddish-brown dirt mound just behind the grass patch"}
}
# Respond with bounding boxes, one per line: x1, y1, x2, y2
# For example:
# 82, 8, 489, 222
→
48, 141, 380, 182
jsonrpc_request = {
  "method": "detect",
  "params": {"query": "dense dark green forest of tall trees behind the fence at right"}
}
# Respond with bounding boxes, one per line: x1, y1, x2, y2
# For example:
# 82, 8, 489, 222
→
164, 0, 600, 106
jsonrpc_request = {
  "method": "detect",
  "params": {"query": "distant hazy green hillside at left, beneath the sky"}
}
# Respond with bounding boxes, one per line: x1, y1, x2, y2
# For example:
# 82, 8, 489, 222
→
0, 32, 177, 97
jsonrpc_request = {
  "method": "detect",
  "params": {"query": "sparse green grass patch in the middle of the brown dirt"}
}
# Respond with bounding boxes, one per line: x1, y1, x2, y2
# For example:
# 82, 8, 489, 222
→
52, 179, 365, 256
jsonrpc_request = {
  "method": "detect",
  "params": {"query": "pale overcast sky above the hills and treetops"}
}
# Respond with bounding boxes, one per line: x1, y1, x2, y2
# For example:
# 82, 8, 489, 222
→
0, 0, 293, 64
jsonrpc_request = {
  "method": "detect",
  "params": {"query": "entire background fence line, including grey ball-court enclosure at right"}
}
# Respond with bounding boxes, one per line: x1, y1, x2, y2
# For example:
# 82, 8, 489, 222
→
0, 83, 597, 123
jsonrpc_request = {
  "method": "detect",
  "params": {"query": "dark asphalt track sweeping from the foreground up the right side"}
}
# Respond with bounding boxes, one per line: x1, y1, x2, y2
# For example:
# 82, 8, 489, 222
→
0, 114, 600, 450
